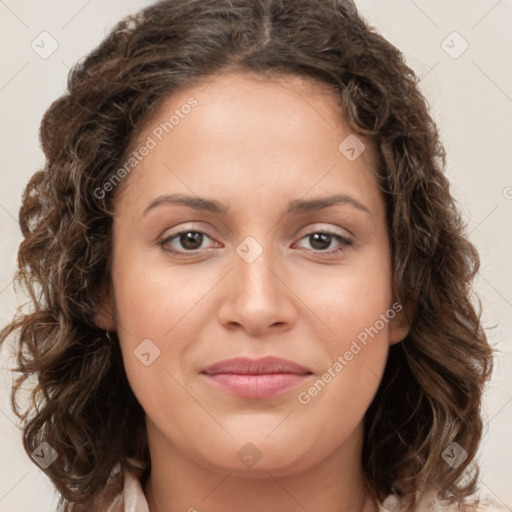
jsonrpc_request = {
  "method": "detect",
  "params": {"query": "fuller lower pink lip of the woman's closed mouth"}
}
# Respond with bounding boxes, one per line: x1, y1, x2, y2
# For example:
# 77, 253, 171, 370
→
202, 373, 310, 398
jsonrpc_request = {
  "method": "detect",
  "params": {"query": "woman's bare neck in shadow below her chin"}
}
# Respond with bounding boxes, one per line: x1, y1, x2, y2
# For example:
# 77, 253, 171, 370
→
144, 424, 378, 512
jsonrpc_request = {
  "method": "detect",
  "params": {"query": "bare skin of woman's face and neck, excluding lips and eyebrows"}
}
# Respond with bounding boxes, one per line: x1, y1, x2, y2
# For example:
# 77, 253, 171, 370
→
100, 73, 407, 512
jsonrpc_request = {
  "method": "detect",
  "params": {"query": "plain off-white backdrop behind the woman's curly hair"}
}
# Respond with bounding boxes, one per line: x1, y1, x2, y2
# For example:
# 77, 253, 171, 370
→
0, 0, 512, 512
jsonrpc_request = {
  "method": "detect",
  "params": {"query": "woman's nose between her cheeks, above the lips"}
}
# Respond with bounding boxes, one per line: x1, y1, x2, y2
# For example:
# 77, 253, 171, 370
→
218, 242, 298, 336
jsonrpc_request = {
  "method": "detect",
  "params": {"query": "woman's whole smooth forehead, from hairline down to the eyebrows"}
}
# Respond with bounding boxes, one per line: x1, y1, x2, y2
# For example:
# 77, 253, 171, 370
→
114, 73, 382, 216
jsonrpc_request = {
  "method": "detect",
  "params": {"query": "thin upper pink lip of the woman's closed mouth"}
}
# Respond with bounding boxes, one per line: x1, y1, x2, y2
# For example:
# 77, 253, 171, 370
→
201, 356, 311, 375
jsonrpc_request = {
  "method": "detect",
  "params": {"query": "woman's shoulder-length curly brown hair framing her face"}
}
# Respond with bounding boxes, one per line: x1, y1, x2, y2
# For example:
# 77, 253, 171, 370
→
0, 0, 493, 511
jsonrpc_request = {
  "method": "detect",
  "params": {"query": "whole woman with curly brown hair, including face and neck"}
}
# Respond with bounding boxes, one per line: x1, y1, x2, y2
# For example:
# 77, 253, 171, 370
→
0, 0, 492, 512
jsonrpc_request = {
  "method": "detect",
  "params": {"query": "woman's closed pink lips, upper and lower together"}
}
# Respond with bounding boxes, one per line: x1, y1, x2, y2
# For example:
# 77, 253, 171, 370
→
201, 357, 312, 398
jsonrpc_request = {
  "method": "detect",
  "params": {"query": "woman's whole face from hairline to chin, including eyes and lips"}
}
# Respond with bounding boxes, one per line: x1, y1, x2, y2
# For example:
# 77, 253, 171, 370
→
106, 74, 407, 475
